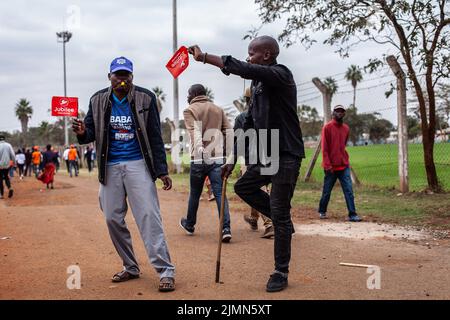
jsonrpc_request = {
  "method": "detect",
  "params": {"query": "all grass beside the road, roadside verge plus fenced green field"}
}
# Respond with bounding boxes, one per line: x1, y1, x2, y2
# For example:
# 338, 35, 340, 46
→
164, 143, 450, 229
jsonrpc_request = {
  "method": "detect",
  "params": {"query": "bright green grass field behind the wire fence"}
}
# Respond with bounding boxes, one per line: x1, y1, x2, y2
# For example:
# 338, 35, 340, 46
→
301, 143, 450, 191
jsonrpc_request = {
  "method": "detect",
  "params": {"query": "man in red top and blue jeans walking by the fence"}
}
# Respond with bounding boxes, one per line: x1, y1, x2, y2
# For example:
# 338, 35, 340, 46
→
319, 105, 362, 222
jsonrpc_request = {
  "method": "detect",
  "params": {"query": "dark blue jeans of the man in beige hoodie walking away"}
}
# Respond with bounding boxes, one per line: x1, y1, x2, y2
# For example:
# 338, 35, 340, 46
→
187, 163, 230, 230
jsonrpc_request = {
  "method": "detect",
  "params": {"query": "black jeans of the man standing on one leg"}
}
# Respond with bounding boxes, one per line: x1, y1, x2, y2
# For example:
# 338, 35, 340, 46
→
234, 156, 301, 273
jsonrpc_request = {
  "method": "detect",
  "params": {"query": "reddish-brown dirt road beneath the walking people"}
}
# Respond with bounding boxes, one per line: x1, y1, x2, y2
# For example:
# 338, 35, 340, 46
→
0, 174, 450, 299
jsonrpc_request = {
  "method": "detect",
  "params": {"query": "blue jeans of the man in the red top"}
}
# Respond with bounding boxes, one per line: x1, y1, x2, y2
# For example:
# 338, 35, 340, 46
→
319, 167, 356, 216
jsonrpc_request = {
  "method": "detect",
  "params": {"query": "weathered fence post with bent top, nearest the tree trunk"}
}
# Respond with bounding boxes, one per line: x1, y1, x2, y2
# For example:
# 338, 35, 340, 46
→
386, 55, 409, 193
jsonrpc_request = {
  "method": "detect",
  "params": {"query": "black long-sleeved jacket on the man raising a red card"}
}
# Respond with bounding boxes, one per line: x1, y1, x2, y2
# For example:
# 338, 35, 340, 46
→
222, 56, 305, 158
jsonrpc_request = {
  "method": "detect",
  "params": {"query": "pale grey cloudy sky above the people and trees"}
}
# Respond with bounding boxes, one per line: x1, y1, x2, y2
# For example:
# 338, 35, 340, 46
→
0, 0, 396, 131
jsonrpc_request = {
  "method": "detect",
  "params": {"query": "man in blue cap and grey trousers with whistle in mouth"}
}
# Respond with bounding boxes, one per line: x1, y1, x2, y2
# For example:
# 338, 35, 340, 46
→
72, 57, 175, 291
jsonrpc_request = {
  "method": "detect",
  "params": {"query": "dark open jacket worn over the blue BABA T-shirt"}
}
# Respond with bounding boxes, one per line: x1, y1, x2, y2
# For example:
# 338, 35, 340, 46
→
77, 86, 168, 184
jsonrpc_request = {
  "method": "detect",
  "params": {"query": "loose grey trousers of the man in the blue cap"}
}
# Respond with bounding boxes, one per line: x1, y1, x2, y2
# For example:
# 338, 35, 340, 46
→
99, 160, 175, 278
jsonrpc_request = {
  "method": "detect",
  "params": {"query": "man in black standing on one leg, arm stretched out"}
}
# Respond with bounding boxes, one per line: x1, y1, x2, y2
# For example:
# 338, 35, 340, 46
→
189, 36, 305, 292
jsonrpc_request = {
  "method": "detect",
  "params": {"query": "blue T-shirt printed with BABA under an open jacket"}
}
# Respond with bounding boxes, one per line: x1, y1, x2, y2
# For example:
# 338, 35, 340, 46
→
108, 94, 143, 164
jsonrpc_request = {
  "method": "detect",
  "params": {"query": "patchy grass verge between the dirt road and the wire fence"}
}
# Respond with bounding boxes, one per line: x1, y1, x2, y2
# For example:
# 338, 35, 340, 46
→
167, 173, 450, 230
